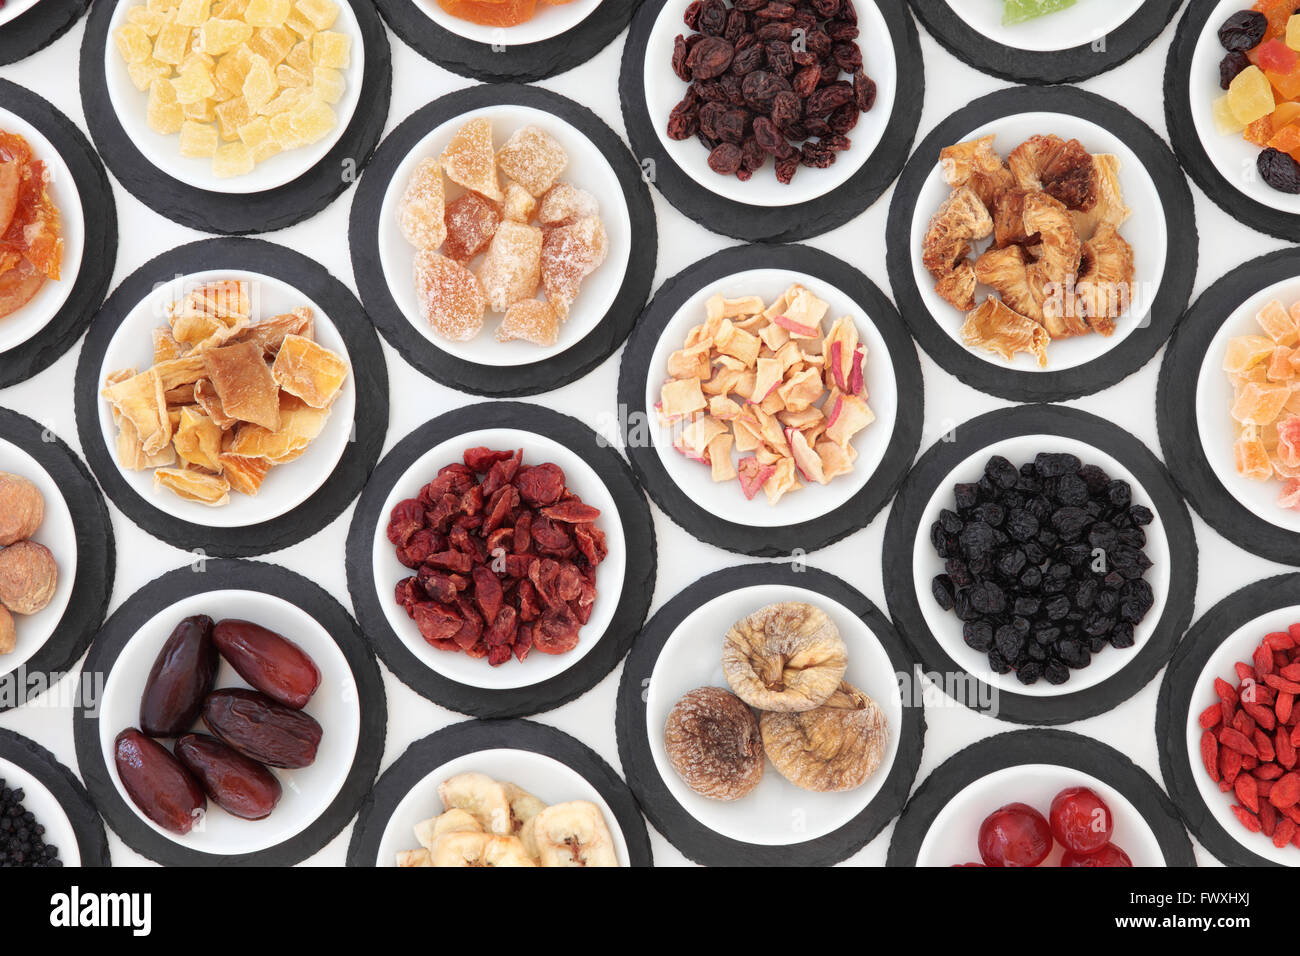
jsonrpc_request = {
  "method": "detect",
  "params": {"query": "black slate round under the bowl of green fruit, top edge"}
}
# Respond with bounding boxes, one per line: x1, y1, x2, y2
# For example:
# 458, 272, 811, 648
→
911, 0, 1183, 83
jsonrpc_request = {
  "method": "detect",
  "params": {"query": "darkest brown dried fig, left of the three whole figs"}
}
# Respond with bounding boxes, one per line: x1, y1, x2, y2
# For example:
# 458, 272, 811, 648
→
663, 687, 764, 800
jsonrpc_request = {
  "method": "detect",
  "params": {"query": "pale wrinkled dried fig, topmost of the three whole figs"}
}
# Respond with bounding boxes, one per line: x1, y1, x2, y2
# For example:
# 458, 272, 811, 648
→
723, 601, 849, 711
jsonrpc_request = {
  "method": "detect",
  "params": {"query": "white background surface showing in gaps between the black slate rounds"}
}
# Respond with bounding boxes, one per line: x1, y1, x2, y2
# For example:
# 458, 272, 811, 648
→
0, 1, 1288, 865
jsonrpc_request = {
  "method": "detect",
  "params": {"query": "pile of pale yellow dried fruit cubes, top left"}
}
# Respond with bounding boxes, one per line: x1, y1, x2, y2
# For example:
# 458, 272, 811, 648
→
113, 0, 352, 178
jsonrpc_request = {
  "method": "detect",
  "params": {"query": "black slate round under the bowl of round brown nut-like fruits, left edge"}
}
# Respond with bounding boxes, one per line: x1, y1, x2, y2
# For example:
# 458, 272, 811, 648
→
0, 408, 117, 713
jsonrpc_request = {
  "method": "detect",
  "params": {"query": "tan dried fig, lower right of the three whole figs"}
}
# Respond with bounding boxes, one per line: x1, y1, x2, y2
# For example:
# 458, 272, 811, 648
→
759, 680, 889, 793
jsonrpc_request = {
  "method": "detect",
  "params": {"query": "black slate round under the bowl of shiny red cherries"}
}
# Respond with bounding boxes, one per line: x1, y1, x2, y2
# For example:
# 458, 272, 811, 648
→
885, 730, 1196, 866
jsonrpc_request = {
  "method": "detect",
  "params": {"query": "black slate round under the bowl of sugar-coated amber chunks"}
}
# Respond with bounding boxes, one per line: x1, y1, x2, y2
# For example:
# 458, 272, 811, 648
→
348, 83, 658, 398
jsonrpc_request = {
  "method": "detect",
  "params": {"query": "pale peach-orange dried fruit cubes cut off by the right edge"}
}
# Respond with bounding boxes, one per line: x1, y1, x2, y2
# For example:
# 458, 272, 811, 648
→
1223, 299, 1300, 509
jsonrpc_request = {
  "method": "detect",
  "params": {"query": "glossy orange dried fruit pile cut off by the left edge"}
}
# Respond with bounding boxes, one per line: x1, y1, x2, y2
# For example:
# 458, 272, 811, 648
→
0, 130, 64, 319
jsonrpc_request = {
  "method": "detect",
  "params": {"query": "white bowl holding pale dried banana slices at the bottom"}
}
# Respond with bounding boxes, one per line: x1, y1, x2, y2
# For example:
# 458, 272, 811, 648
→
374, 748, 628, 866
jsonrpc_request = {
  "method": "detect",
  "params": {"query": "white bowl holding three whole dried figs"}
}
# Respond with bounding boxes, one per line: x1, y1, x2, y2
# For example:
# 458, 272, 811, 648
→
646, 584, 902, 847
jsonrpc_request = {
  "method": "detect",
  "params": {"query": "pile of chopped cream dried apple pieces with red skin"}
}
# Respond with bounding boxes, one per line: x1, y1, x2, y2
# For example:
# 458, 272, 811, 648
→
655, 285, 875, 505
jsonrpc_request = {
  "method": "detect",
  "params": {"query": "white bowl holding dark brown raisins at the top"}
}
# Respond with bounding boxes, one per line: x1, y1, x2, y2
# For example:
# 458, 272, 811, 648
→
644, 0, 900, 206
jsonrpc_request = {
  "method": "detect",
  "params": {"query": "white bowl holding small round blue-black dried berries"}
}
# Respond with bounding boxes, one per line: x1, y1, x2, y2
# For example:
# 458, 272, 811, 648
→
911, 434, 1171, 697
